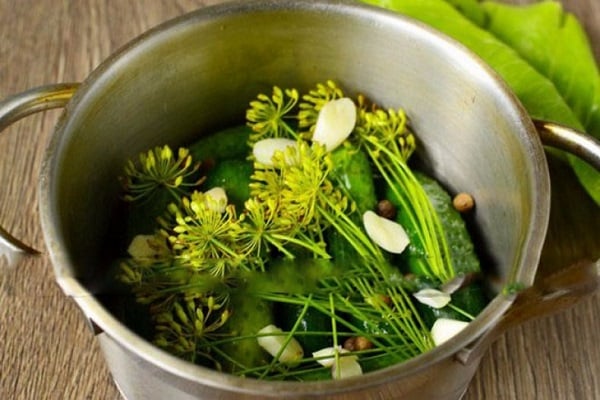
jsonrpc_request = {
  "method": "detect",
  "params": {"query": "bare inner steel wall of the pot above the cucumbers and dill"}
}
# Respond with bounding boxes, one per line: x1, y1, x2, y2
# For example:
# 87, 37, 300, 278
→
41, 1, 549, 394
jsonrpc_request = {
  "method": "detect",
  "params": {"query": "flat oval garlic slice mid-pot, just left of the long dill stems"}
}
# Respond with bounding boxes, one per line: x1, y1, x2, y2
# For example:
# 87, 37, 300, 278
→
363, 211, 410, 254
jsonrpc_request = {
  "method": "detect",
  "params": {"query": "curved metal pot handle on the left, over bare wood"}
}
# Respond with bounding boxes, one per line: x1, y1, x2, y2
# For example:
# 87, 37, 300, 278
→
0, 83, 79, 265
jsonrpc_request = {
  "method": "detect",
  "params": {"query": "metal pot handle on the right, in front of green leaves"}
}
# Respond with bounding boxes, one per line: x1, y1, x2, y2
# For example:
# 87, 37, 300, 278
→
533, 120, 600, 171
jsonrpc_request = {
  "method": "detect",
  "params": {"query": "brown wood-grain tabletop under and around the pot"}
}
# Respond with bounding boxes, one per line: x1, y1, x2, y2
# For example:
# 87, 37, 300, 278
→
0, 0, 600, 400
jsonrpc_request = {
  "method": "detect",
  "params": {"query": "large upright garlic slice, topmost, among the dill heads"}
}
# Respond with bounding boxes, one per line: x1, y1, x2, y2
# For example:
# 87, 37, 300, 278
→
312, 97, 356, 151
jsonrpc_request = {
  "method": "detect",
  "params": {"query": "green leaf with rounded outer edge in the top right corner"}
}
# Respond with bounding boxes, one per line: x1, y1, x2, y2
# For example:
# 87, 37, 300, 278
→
481, 1, 600, 204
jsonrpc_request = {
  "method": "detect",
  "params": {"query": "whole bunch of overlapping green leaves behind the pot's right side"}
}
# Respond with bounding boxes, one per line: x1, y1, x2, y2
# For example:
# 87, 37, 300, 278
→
366, 0, 600, 205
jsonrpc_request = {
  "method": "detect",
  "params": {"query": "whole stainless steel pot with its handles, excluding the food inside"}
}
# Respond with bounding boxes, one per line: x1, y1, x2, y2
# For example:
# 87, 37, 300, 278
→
0, 0, 600, 400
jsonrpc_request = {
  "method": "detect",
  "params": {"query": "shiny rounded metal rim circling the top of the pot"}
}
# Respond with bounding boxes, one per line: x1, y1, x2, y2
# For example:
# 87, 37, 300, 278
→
39, 0, 550, 395
